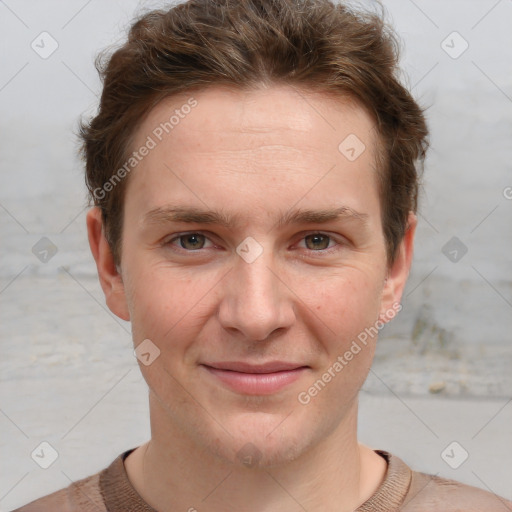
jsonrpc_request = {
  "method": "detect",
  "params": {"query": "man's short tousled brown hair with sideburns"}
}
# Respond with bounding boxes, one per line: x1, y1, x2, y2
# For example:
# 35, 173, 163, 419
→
80, 0, 428, 263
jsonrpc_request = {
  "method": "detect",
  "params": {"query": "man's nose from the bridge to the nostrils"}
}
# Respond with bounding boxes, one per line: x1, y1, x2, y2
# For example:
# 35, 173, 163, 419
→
218, 245, 295, 341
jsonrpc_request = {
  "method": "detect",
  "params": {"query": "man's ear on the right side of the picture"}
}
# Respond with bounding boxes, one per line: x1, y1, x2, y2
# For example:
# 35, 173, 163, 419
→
380, 212, 418, 322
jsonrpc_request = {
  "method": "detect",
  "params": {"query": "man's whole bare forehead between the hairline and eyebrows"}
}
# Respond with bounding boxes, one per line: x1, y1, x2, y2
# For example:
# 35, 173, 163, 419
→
127, 86, 377, 223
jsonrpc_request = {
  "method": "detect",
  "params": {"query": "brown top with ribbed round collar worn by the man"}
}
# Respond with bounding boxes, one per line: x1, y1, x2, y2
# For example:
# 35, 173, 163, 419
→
13, 448, 512, 512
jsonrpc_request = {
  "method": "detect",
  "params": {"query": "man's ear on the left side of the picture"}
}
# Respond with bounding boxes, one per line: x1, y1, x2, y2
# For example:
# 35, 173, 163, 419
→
87, 207, 130, 321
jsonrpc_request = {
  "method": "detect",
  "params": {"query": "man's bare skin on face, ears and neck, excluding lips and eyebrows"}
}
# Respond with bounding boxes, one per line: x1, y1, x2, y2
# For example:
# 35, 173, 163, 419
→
87, 85, 416, 512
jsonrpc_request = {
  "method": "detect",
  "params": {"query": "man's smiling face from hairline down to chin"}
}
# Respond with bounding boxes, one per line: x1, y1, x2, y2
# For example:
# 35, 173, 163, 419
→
93, 86, 414, 464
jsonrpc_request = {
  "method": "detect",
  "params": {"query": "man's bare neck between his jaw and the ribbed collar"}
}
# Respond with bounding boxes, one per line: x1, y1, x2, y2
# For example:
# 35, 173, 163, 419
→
125, 394, 386, 512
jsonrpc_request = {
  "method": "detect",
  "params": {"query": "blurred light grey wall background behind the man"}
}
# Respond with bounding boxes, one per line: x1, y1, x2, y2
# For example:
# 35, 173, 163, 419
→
0, 0, 512, 510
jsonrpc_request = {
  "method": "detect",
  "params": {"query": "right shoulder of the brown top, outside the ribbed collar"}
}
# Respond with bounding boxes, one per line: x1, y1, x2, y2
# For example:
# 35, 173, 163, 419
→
401, 471, 512, 512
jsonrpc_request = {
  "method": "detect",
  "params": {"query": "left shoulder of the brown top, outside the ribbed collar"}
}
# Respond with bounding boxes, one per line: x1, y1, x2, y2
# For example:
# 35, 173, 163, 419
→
12, 473, 107, 512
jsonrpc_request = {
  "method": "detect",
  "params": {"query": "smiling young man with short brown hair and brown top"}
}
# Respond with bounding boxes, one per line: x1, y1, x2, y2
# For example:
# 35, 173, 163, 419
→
13, 0, 512, 512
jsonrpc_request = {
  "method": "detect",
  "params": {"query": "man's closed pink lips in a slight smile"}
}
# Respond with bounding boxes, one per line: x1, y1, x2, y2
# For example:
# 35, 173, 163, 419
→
200, 361, 309, 395
